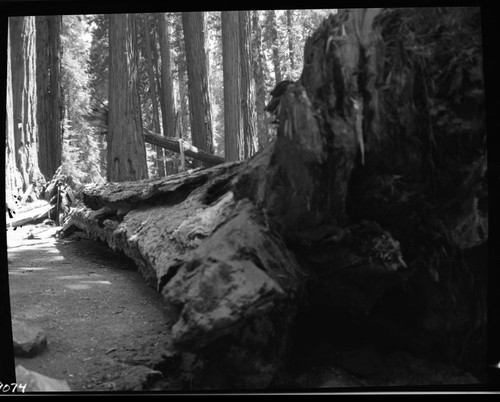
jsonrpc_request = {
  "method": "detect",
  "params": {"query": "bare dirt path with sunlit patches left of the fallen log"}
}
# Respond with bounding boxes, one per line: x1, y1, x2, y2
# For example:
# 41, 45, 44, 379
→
7, 221, 174, 391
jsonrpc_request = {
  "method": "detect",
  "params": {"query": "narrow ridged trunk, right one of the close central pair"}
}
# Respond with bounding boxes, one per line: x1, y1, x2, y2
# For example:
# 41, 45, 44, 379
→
238, 11, 257, 159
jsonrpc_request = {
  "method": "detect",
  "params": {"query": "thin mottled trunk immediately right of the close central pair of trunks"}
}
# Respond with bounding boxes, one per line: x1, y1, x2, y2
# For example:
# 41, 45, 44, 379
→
252, 11, 269, 151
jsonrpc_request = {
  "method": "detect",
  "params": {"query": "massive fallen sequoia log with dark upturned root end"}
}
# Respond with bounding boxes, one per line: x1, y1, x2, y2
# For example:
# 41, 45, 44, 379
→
60, 9, 488, 388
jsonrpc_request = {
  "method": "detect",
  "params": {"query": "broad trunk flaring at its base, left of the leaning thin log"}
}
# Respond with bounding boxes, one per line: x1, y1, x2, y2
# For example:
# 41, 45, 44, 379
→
107, 14, 148, 182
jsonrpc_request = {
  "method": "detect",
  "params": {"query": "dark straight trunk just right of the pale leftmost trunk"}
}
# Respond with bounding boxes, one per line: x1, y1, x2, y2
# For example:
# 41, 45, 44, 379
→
36, 15, 62, 180
